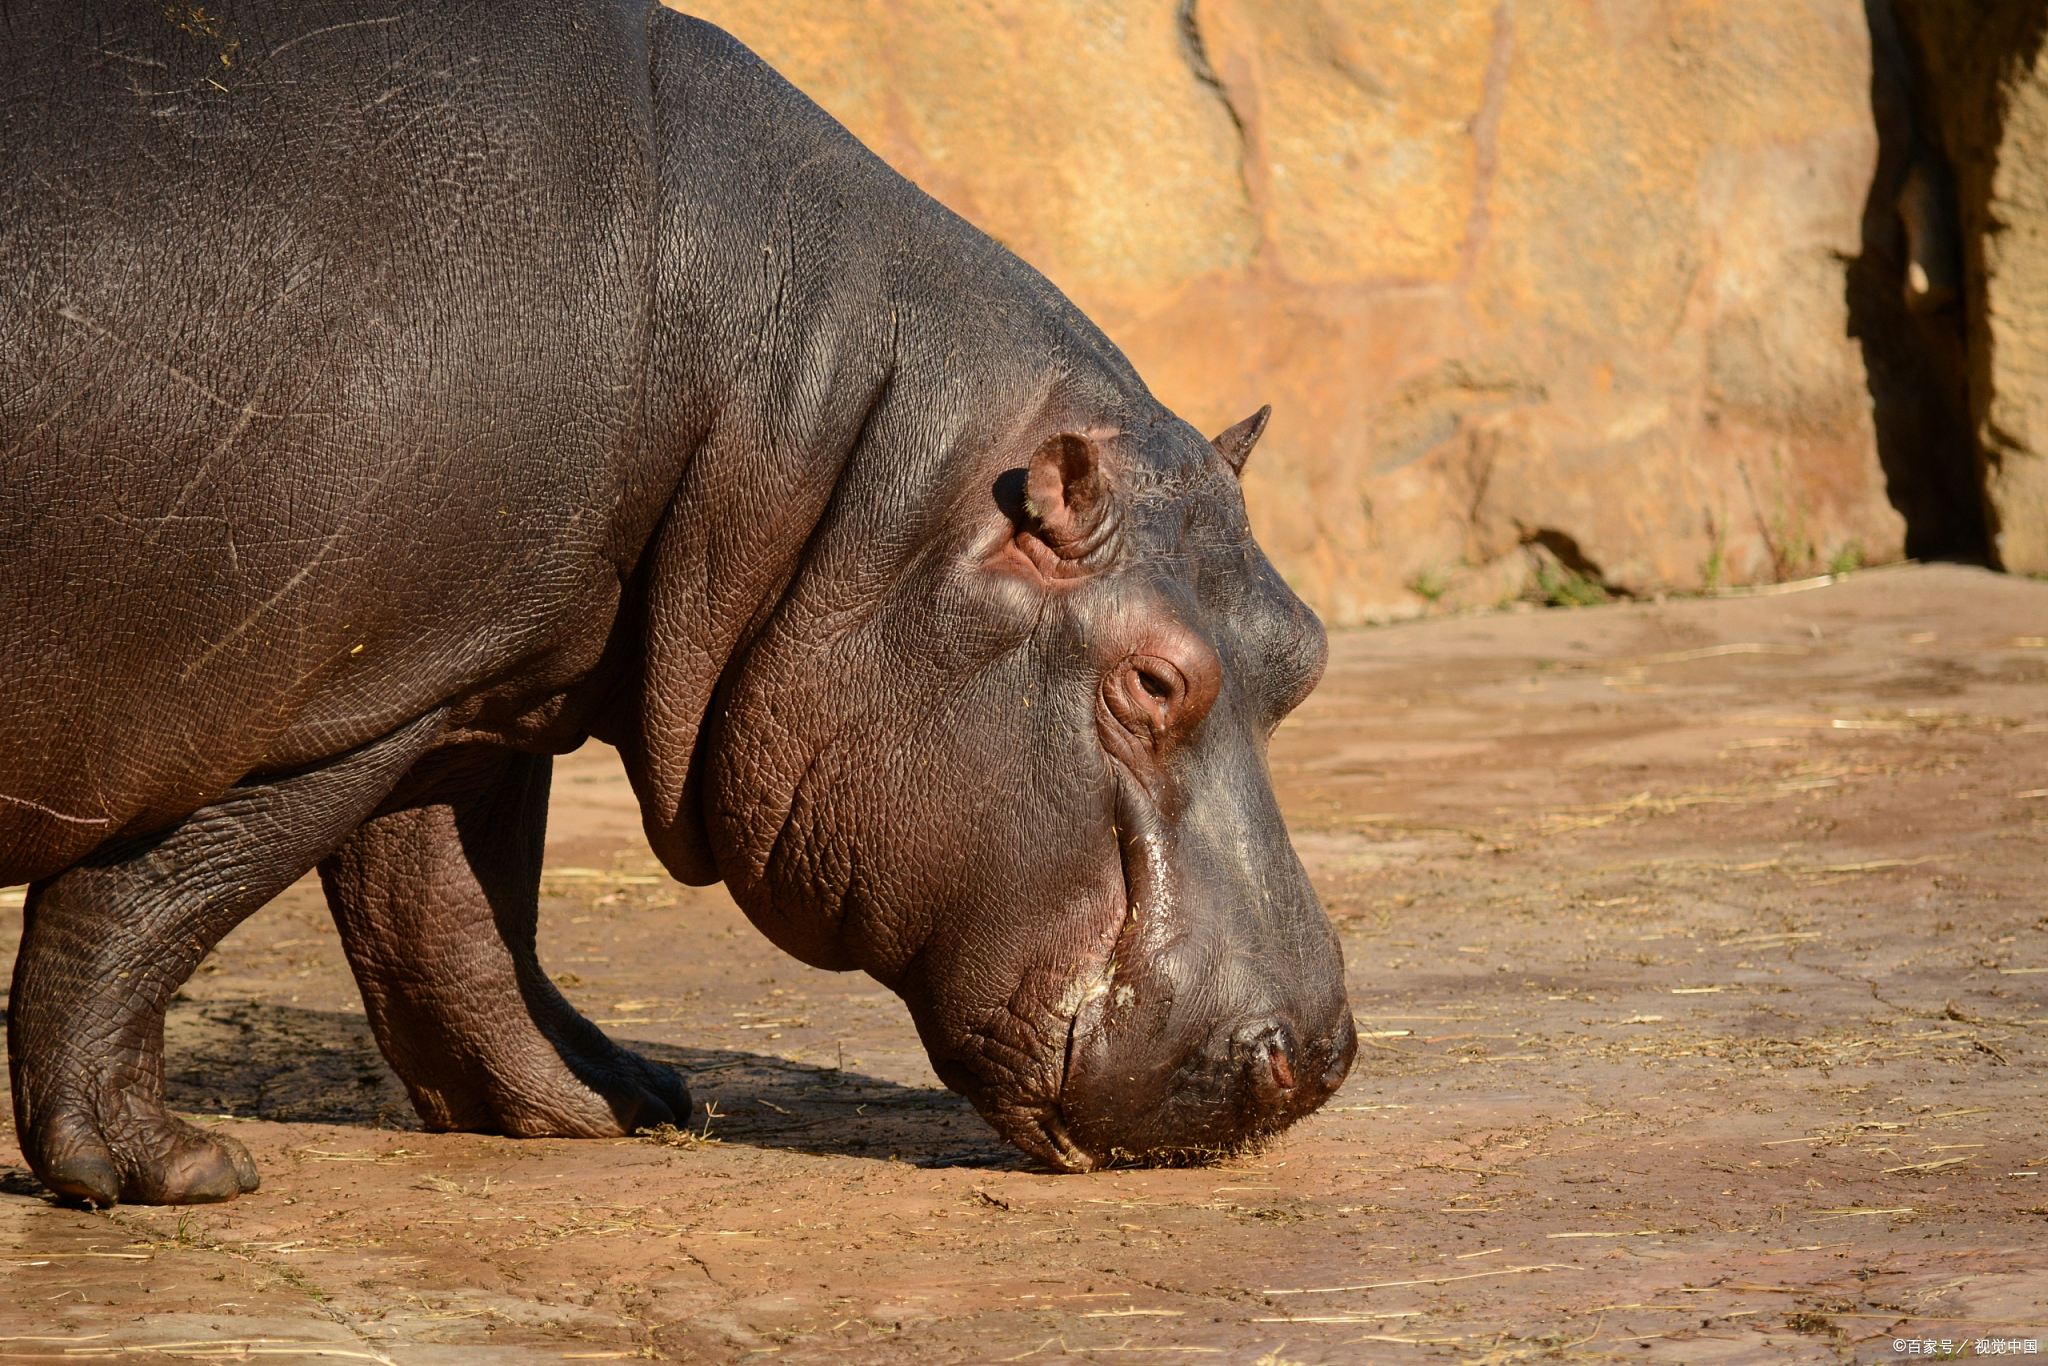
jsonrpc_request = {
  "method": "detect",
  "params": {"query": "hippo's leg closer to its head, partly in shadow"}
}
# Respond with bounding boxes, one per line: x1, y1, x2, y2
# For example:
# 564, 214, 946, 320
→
319, 745, 690, 1137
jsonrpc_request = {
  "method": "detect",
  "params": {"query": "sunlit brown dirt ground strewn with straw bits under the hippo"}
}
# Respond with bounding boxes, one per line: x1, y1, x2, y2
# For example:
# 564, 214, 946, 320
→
0, 565, 2048, 1366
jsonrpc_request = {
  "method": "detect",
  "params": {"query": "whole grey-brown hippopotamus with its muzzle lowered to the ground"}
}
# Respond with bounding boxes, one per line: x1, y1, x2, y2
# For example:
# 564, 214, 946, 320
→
0, 0, 1356, 1206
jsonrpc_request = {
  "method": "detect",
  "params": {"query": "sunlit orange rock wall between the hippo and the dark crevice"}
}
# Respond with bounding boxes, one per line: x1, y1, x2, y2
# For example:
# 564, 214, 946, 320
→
690, 0, 1905, 625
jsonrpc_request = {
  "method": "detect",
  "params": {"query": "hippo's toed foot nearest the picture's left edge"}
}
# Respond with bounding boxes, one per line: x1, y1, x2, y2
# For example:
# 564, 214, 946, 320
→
25, 1112, 262, 1208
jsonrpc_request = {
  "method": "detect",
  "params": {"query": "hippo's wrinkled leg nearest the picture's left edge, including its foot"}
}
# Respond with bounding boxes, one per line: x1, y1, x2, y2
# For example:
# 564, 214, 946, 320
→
8, 713, 440, 1204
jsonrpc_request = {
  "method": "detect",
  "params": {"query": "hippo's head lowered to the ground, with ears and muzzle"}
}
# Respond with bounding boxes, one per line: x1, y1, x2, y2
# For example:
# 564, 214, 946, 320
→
698, 405, 1356, 1169
